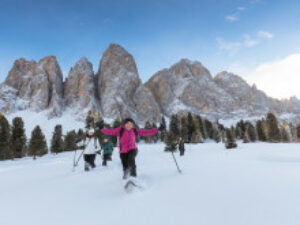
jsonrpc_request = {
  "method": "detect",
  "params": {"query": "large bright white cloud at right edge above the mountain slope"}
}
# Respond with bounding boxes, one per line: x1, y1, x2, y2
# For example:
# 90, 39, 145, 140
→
233, 53, 300, 99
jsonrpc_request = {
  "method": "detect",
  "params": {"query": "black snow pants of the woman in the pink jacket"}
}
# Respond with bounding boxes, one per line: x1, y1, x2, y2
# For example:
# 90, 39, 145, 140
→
120, 149, 138, 177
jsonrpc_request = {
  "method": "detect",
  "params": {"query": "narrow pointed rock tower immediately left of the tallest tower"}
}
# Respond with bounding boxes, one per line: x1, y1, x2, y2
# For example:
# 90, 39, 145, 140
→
64, 57, 100, 112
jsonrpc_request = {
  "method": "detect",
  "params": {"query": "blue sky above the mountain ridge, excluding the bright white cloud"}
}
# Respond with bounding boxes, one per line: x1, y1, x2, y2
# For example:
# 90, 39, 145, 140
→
0, 0, 300, 98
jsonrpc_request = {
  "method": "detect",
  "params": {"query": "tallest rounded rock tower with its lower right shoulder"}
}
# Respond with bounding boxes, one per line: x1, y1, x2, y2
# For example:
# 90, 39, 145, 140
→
97, 44, 160, 121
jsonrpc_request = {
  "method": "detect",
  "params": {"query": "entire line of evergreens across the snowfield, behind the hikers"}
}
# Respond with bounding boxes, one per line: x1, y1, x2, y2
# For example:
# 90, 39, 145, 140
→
0, 111, 300, 160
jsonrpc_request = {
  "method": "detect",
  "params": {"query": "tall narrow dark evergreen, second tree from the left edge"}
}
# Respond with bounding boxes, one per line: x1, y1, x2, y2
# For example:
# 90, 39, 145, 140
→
10, 117, 26, 158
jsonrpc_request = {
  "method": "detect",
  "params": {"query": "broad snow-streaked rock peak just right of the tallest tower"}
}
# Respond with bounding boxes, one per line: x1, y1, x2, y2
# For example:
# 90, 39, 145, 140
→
146, 59, 233, 117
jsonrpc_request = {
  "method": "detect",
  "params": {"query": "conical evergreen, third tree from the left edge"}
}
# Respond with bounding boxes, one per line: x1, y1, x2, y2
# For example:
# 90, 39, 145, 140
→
28, 126, 48, 159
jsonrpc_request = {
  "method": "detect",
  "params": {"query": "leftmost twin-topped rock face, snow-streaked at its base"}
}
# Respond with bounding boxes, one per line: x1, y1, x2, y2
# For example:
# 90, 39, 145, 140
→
4, 56, 63, 116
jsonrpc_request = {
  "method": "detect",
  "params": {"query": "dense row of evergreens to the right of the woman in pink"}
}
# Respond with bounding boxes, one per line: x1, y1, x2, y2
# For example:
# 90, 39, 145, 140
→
161, 113, 300, 149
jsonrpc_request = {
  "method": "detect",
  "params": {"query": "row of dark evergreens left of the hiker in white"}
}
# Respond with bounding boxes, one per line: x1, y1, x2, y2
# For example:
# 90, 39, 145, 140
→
0, 113, 84, 160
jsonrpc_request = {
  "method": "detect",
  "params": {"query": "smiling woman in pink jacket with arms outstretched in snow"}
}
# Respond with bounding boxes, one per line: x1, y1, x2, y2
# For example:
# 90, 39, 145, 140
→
98, 118, 164, 179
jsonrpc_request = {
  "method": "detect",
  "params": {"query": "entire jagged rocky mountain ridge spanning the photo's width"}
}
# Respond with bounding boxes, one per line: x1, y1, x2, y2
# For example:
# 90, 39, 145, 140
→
0, 44, 300, 122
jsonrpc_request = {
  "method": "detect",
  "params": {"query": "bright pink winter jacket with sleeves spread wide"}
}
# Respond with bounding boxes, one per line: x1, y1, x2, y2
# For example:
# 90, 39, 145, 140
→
101, 126, 158, 153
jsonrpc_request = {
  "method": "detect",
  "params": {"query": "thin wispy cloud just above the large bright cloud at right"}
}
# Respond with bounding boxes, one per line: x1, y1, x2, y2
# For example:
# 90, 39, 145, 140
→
216, 34, 259, 56
